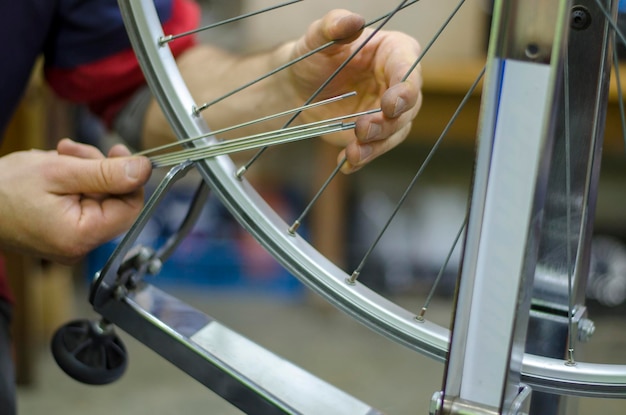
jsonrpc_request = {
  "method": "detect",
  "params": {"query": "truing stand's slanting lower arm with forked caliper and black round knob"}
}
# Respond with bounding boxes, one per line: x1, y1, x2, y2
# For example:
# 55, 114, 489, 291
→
55, 158, 386, 415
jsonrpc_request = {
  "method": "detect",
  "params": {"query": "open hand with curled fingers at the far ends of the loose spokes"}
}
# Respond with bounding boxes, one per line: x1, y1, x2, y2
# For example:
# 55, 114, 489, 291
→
283, 10, 422, 173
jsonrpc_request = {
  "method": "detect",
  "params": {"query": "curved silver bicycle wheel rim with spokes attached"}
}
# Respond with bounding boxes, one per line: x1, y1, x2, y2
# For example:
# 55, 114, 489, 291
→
107, 0, 626, 412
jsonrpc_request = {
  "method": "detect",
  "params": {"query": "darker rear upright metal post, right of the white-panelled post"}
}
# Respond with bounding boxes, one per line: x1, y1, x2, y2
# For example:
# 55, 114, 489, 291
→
526, 0, 617, 415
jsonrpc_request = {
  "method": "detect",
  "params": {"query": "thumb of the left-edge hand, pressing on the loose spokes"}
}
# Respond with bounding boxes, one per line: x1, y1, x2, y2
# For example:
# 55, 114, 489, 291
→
53, 156, 152, 194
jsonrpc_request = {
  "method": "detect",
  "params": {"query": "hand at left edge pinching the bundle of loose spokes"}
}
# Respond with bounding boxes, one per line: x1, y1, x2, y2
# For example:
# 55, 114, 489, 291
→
0, 139, 151, 263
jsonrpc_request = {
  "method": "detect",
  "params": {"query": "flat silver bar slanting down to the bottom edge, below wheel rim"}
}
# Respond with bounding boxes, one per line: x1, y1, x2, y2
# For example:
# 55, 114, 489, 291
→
96, 284, 381, 415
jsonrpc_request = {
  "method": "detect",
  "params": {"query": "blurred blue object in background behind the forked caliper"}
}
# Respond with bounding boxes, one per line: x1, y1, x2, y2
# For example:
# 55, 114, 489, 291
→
87, 184, 306, 300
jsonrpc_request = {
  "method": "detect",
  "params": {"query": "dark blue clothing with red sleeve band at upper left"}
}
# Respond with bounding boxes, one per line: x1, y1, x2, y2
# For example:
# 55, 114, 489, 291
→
0, 0, 199, 135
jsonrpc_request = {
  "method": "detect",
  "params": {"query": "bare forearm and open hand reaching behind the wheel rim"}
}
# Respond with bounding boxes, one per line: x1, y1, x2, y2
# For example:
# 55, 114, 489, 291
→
142, 10, 421, 172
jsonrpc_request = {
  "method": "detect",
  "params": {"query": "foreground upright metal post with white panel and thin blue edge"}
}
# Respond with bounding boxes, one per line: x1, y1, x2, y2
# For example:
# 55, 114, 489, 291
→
436, 0, 570, 414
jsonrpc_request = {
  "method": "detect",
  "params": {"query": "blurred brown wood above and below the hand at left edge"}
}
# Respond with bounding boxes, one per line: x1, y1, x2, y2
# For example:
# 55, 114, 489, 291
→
0, 69, 73, 385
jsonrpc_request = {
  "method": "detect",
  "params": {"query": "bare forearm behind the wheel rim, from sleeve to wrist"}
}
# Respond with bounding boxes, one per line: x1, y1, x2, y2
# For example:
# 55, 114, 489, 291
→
142, 40, 298, 148
